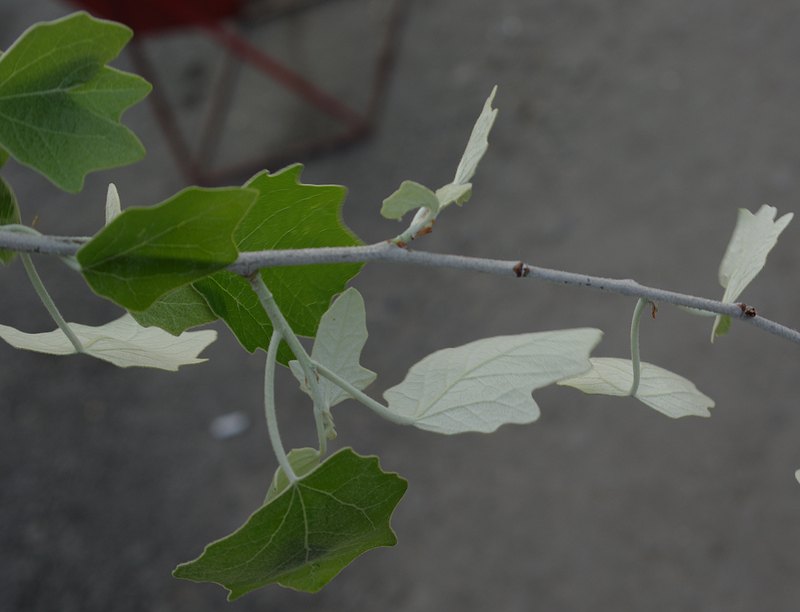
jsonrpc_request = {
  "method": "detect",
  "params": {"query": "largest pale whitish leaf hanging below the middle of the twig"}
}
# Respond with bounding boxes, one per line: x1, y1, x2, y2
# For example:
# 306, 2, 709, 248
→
384, 328, 603, 434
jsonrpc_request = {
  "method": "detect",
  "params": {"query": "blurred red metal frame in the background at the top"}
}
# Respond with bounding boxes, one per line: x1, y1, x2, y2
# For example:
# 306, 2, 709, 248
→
65, 0, 408, 184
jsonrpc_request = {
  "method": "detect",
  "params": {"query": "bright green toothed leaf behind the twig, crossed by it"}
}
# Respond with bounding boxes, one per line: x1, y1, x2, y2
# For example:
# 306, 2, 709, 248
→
203, 164, 362, 358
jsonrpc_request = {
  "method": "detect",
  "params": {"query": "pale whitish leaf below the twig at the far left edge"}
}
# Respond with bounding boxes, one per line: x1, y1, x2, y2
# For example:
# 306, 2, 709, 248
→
0, 314, 217, 371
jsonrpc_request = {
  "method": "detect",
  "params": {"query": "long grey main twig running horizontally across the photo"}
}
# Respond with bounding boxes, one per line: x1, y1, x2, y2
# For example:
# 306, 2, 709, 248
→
0, 230, 800, 344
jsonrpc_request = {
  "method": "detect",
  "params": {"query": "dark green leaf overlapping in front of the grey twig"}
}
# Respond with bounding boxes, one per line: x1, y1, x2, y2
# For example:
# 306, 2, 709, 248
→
77, 187, 256, 310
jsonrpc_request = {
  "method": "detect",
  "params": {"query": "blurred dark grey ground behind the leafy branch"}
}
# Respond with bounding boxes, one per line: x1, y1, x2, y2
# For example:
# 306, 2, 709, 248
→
0, 0, 800, 612
